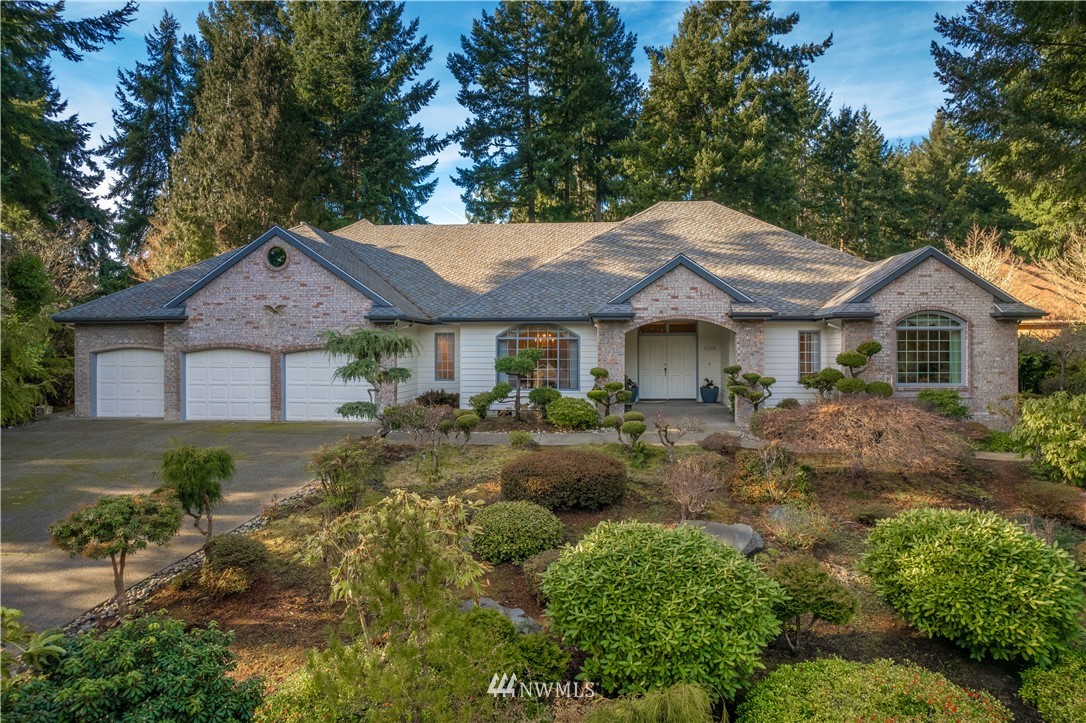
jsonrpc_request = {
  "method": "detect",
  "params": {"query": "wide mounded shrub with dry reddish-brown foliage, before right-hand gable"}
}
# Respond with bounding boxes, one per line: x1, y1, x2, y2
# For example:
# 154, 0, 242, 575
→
755, 395, 969, 473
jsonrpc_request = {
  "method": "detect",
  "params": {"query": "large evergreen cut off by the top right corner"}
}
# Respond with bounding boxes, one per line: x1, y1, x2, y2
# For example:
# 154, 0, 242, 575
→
932, 1, 1086, 255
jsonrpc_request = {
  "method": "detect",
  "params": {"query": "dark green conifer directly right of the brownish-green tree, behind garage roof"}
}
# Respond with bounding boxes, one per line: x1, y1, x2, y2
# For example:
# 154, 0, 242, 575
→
287, 2, 449, 224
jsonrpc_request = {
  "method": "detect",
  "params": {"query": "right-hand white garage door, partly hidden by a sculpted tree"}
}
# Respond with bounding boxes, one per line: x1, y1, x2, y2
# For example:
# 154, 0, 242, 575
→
282, 350, 369, 421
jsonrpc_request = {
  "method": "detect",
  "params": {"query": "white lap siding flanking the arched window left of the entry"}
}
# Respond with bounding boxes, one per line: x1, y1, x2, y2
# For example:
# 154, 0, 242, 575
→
456, 324, 597, 407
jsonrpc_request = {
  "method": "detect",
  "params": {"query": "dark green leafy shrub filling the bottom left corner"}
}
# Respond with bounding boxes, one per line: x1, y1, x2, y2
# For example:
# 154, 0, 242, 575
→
2, 613, 264, 723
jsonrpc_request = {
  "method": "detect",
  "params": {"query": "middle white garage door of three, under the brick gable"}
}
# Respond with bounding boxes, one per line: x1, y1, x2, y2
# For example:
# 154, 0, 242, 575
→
185, 348, 272, 419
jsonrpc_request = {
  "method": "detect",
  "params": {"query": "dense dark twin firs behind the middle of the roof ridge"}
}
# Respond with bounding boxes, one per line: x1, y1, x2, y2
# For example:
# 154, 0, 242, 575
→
449, 1, 637, 223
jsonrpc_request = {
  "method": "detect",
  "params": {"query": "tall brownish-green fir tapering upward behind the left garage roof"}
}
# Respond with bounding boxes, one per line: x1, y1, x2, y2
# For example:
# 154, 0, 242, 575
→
137, 2, 323, 278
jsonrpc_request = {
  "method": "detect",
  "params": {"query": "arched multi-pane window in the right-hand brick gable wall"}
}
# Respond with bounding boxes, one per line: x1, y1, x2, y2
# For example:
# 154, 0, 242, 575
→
897, 312, 964, 386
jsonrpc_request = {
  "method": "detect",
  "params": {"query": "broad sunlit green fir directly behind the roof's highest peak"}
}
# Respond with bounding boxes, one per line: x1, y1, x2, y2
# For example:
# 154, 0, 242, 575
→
629, 0, 832, 224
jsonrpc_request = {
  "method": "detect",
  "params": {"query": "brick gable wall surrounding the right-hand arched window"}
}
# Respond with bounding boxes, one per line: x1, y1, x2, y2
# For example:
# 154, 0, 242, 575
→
860, 258, 1018, 428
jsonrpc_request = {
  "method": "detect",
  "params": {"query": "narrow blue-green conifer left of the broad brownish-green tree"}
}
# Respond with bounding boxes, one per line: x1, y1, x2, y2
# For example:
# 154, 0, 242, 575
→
100, 11, 193, 254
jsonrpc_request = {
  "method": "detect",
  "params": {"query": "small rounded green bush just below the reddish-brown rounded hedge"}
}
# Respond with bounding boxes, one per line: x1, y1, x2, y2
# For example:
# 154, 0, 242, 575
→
471, 500, 561, 562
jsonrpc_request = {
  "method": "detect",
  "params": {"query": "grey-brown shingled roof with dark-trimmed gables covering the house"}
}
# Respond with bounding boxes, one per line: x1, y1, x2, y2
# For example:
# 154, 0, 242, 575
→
54, 201, 1040, 322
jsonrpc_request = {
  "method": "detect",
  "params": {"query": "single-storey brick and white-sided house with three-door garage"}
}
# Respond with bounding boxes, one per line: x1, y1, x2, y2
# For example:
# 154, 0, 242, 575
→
54, 202, 1044, 422
